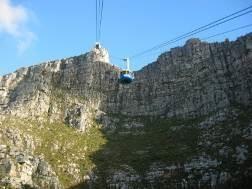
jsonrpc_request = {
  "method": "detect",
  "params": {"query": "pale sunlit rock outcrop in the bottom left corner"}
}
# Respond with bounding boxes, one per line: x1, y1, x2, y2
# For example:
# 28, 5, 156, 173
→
0, 123, 61, 189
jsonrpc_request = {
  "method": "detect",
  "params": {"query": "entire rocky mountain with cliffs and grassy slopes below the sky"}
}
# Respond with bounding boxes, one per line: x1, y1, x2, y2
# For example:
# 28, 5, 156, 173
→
0, 34, 252, 188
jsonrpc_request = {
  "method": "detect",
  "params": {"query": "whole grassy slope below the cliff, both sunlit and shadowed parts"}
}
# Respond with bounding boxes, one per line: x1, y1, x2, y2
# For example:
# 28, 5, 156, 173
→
1, 113, 201, 187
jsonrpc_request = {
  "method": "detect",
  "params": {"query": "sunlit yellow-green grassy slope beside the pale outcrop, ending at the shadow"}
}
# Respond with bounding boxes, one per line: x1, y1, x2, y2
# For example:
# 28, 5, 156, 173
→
1, 117, 106, 188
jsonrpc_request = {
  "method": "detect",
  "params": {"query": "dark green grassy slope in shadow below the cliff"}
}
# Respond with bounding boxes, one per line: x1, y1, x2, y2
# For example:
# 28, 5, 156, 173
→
92, 115, 200, 182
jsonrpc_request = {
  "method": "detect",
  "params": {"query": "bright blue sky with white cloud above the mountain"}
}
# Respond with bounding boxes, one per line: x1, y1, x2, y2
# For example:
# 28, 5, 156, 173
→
0, 0, 252, 75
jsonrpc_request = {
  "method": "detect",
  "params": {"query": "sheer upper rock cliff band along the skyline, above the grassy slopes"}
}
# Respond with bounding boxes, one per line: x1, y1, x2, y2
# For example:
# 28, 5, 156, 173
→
0, 34, 252, 117
